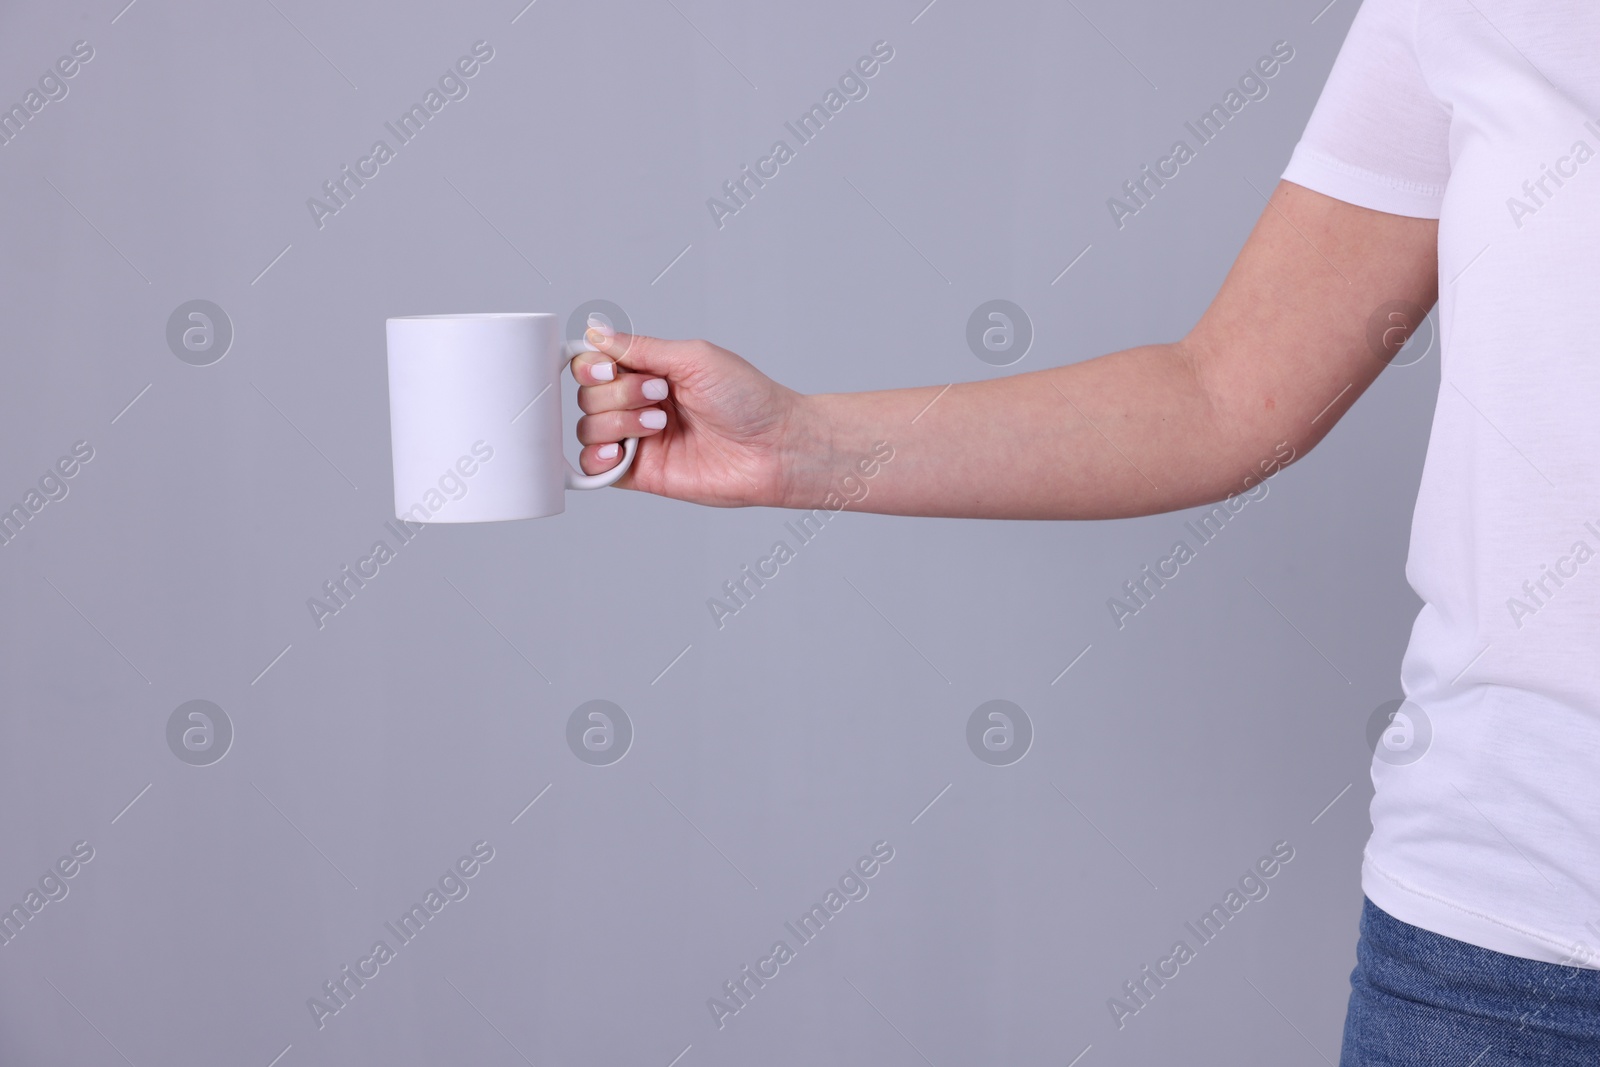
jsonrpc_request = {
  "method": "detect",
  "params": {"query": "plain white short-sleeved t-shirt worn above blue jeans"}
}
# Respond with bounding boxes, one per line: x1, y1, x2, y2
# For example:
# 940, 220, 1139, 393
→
1283, 0, 1600, 966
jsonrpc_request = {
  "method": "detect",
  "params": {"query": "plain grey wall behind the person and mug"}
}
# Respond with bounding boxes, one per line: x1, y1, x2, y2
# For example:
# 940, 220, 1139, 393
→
0, 0, 1438, 1067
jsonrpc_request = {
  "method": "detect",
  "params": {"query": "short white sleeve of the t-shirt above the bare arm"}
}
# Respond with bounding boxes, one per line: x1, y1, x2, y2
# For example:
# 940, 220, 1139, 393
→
1283, 0, 1450, 219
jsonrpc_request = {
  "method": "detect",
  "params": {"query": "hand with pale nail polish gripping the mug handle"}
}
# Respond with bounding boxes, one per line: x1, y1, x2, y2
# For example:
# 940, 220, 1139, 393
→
571, 328, 814, 507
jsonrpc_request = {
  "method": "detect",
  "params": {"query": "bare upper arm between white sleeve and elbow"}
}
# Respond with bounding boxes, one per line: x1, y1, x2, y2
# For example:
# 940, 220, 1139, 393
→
1178, 181, 1438, 466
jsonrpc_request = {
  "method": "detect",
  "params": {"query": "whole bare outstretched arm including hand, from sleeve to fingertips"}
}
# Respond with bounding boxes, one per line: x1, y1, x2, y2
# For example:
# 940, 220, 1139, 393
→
571, 182, 1438, 518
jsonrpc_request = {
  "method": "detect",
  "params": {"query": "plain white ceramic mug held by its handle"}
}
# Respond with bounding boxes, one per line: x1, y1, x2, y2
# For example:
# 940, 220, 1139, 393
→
387, 312, 638, 523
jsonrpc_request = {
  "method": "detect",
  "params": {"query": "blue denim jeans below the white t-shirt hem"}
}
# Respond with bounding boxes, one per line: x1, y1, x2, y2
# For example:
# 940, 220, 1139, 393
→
1339, 901, 1600, 1067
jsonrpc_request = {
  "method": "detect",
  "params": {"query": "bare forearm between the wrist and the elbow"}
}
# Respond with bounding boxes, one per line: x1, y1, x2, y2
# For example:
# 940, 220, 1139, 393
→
782, 344, 1294, 518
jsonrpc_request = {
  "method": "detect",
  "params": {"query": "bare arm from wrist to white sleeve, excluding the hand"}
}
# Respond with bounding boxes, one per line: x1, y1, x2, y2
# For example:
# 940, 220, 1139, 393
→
761, 182, 1438, 518
